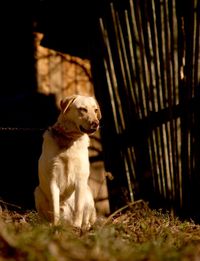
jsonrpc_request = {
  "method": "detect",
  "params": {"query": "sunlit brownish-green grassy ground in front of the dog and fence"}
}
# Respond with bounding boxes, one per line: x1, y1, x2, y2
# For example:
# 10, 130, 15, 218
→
0, 201, 200, 261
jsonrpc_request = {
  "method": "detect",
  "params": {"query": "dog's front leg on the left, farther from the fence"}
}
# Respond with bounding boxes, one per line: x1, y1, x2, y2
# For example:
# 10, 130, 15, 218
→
50, 181, 60, 225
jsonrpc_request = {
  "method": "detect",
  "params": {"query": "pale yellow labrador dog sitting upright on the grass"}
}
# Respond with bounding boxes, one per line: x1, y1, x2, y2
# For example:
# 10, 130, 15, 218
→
34, 95, 101, 229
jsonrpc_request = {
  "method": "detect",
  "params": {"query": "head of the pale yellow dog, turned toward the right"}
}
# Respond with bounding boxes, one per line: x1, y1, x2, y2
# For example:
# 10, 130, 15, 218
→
60, 95, 101, 134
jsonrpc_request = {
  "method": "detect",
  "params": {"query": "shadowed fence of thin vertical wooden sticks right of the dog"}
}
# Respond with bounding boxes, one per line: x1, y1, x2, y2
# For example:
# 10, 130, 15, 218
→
93, 0, 200, 219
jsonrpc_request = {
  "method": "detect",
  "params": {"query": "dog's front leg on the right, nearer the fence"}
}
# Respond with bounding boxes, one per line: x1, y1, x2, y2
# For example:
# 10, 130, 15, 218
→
74, 182, 87, 228
